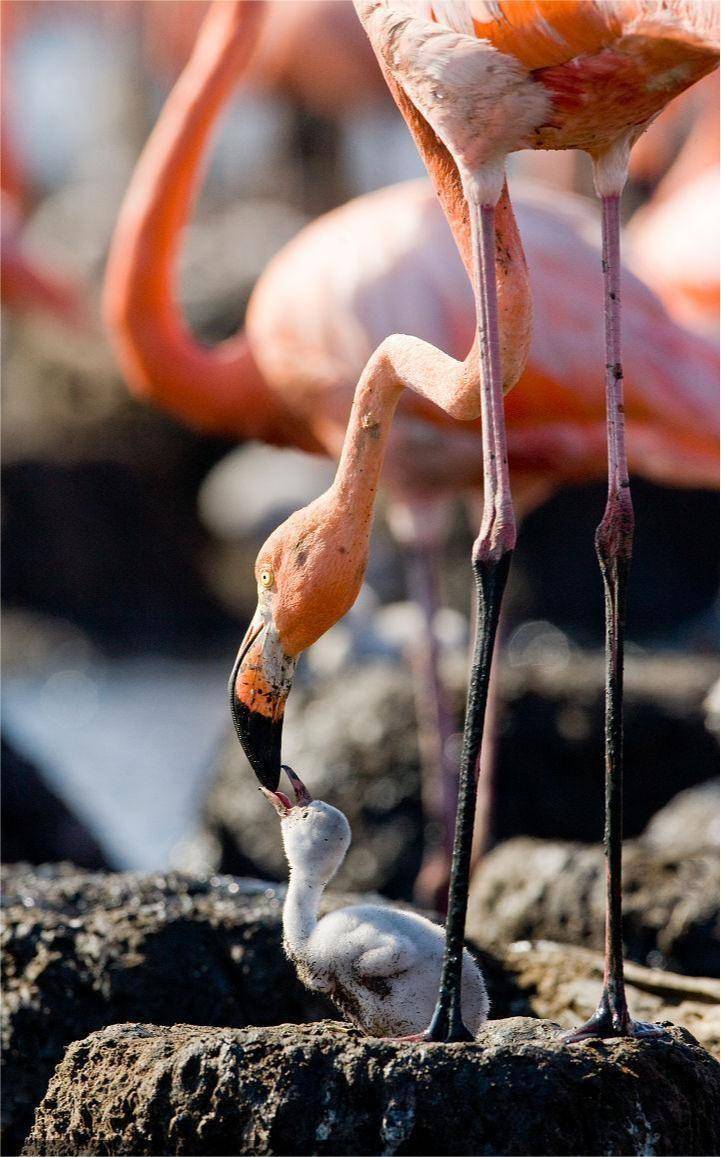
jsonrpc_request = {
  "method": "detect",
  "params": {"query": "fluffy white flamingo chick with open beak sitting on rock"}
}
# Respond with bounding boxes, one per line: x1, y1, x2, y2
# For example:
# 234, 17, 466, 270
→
260, 767, 488, 1037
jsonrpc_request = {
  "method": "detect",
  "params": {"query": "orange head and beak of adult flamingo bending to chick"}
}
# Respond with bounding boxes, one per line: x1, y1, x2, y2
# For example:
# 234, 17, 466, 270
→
229, 487, 368, 791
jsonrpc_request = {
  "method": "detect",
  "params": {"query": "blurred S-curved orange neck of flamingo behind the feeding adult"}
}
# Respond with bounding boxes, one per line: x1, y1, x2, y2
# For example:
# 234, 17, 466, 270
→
103, 0, 312, 443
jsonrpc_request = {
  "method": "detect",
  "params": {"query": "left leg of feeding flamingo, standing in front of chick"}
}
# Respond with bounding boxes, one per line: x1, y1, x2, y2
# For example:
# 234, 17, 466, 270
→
426, 199, 516, 1041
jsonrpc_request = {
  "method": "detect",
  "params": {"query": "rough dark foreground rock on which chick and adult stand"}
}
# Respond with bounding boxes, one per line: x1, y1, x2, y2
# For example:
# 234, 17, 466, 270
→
24, 1018, 718, 1155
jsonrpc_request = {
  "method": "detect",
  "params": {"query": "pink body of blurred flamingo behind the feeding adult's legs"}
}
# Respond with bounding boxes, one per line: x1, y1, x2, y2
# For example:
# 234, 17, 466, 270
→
247, 180, 718, 491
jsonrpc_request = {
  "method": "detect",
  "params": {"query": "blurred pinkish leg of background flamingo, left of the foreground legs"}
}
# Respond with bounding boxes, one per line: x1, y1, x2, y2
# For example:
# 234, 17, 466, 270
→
404, 532, 458, 911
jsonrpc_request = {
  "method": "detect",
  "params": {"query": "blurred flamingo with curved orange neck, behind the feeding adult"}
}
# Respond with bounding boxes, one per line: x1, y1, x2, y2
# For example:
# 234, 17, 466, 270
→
104, 3, 716, 920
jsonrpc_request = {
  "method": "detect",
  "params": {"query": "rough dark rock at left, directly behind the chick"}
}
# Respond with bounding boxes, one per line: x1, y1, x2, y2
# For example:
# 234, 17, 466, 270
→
2, 867, 332, 1152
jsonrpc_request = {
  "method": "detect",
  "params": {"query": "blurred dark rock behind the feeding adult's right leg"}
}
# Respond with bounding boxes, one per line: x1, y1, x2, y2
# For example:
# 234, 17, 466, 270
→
488, 652, 719, 842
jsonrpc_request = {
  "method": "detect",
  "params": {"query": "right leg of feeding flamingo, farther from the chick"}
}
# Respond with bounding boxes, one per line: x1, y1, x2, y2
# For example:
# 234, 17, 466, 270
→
565, 194, 662, 1041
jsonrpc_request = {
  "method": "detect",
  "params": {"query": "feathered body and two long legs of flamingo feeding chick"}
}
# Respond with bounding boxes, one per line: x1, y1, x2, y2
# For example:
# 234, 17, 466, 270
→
355, 0, 718, 1039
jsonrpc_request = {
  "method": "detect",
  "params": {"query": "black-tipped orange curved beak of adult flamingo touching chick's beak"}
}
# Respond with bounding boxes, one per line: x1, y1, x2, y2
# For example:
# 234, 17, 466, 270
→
228, 606, 296, 791
